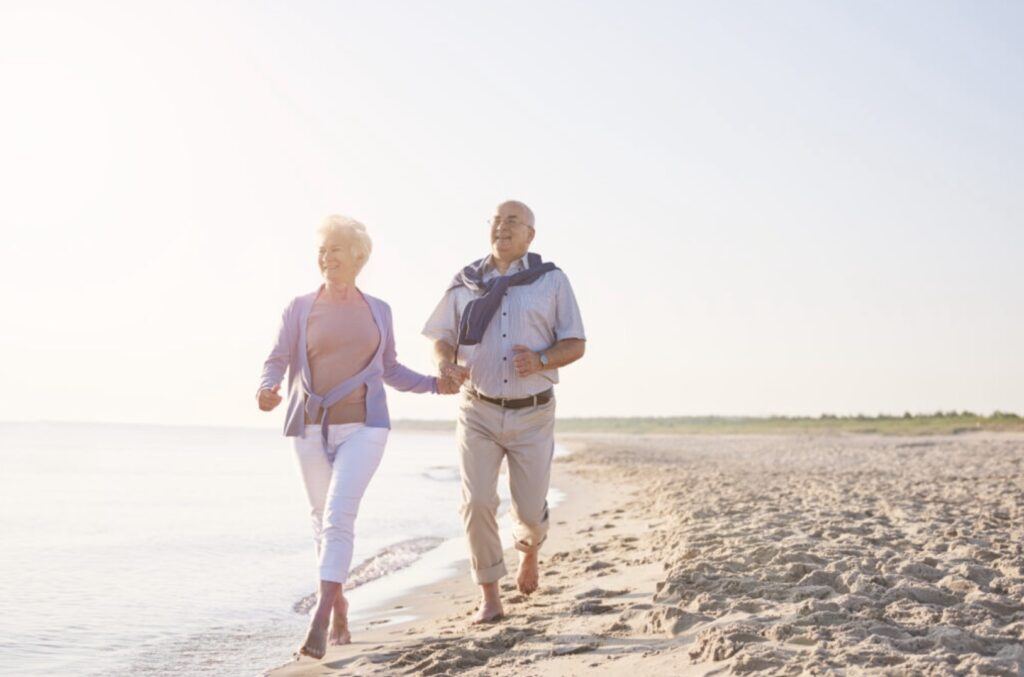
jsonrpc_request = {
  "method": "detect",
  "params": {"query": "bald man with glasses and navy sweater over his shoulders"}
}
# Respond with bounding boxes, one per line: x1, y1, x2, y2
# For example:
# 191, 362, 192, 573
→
423, 201, 586, 623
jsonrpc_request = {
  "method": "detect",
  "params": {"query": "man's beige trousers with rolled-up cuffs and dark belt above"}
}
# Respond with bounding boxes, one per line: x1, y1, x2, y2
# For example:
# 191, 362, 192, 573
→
456, 392, 555, 584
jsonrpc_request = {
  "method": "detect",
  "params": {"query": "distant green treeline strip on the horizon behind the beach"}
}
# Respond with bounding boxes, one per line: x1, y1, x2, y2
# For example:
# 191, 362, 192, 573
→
395, 411, 1024, 435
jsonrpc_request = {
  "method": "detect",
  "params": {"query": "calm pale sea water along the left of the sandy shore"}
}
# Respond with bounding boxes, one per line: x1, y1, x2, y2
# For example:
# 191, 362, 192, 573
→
0, 423, 553, 677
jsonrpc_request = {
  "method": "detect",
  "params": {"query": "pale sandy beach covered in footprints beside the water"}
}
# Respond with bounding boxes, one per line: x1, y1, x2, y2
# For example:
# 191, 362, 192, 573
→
270, 432, 1024, 676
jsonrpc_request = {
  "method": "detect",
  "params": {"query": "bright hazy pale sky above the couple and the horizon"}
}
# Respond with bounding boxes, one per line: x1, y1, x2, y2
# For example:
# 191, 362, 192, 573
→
0, 0, 1024, 426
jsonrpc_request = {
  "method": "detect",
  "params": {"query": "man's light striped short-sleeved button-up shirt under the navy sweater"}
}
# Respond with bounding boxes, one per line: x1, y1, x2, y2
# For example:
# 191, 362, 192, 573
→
423, 256, 587, 398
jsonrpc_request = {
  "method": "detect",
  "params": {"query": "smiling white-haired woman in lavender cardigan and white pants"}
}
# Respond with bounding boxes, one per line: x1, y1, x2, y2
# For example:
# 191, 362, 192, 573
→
257, 216, 460, 659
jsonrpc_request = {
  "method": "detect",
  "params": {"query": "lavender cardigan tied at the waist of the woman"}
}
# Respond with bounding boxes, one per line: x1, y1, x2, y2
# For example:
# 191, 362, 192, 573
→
257, 286, 437, 449
